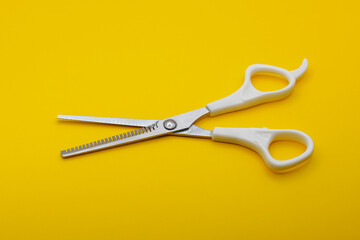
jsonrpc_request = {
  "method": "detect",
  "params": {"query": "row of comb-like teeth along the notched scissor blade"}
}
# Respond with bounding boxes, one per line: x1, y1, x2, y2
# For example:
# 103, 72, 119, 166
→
61, 123, 158, 155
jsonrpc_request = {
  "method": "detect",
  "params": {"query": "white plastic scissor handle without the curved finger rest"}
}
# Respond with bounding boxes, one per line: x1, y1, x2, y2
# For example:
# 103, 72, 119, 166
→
212, 127, 314, 172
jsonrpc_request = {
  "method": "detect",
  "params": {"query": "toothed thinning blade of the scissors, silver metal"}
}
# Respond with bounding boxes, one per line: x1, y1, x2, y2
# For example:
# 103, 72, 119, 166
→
61, 122, 168, 158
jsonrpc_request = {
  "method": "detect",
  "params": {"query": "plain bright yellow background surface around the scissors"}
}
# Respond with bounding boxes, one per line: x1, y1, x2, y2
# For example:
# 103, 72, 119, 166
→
0, 0, 360, 240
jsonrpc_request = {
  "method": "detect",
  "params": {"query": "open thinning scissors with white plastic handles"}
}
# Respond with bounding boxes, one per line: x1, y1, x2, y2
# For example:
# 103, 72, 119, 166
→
58, 59, 314, 172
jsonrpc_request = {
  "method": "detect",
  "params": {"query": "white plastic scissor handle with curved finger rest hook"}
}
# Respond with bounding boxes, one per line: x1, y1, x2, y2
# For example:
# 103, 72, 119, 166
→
206, 58, 308, 116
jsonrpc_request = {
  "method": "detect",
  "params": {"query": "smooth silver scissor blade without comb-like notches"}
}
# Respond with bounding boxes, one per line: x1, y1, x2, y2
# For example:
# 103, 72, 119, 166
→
58, 115, 159, 127
